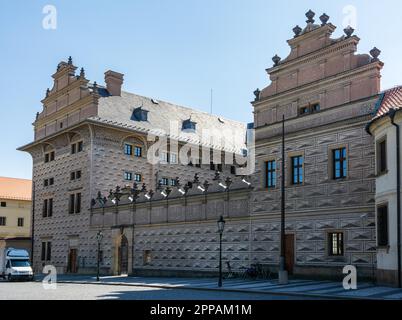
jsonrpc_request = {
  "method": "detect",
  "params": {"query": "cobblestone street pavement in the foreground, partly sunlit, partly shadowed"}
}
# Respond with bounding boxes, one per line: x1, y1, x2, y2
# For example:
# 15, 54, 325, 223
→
0, 281, 314, 301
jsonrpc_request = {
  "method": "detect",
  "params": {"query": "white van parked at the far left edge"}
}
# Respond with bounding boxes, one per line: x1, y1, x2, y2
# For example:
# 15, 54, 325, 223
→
0, 248, 34, 281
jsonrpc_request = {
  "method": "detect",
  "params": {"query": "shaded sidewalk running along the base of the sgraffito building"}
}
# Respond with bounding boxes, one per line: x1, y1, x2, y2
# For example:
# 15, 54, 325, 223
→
37, 275, 402, 300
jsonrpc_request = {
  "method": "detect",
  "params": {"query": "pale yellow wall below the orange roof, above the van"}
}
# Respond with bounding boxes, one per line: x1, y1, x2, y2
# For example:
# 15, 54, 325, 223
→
0, 199, 31, 238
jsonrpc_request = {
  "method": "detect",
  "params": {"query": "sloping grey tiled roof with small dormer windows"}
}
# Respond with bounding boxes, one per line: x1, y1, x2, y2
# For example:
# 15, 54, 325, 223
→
90, 92, 247, 154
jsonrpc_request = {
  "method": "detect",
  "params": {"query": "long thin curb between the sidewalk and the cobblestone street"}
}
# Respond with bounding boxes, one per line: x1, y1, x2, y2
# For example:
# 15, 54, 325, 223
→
36, 280, 384, 301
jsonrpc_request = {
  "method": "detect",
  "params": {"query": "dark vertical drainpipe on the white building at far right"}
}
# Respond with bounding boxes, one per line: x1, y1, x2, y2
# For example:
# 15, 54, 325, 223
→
389, 109, 402, 288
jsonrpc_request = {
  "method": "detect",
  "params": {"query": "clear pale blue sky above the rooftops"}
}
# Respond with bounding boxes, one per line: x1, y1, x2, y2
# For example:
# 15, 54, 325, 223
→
0, 0, 402, 178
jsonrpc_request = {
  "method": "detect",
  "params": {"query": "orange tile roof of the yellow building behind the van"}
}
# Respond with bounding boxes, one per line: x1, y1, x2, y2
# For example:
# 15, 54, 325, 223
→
0, 177, 32, 201
